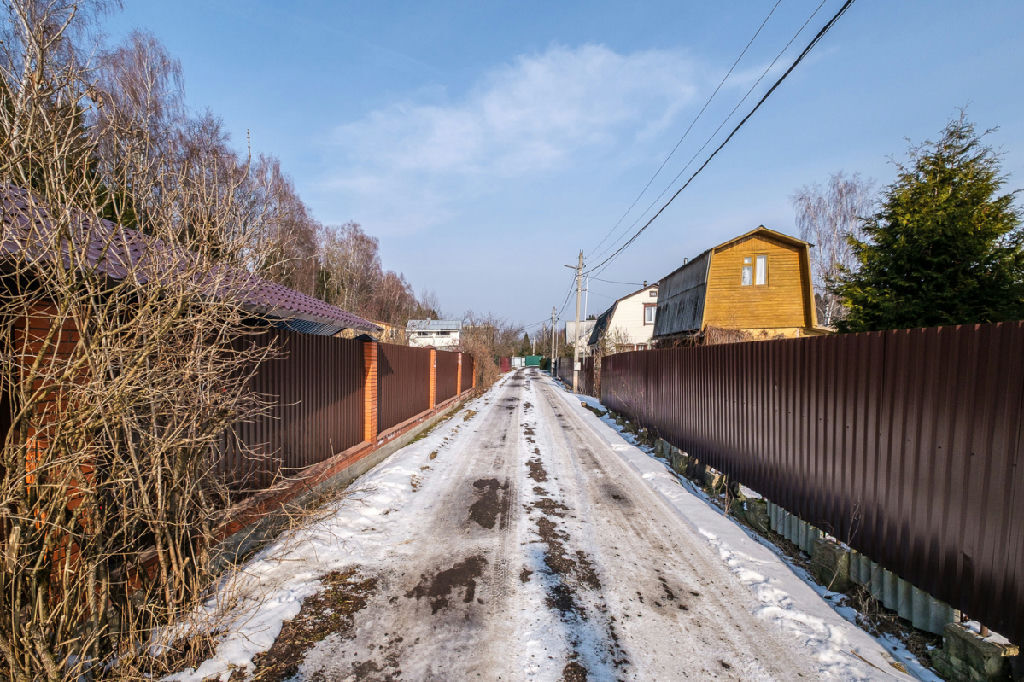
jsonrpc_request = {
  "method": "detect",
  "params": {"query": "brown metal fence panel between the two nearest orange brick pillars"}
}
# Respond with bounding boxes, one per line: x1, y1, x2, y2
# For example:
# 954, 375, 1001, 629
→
377, 343, 430, 433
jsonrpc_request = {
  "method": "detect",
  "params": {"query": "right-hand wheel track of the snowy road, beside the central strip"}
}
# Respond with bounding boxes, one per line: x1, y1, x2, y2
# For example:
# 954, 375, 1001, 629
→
537, 374, 812, 680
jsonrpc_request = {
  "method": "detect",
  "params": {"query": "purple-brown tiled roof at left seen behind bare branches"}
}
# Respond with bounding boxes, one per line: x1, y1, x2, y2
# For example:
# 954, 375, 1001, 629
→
0, 184, 380, 335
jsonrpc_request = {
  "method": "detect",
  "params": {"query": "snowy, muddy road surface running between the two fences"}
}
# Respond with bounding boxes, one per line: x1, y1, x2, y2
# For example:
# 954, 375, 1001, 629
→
176, 371, 925, 680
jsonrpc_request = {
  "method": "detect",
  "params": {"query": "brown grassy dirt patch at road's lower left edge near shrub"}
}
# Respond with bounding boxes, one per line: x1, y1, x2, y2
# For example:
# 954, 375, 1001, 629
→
249, 568, 377, 680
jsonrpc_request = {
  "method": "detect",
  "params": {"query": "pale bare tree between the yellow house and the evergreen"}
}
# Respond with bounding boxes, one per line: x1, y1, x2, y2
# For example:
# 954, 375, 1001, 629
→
791, 171, 874, 327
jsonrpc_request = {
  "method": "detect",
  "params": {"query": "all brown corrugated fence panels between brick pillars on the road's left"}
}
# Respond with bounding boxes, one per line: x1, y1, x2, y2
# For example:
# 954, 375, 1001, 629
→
218, 329, 473, 493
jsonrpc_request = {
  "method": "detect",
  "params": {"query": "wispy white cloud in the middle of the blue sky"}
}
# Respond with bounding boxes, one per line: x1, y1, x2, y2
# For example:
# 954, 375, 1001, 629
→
328, 45, 696, 229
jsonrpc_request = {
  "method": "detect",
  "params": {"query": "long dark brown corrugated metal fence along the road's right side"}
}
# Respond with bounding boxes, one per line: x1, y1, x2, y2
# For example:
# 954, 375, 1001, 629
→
598, 323, 1024, 642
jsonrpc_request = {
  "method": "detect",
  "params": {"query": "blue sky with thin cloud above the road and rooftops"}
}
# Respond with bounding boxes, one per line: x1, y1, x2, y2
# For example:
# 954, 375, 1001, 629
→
106, 0, 1024, 324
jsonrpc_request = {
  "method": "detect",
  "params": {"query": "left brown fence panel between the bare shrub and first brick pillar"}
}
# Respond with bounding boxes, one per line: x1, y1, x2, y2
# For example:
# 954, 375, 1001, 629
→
219, 329, 364, 489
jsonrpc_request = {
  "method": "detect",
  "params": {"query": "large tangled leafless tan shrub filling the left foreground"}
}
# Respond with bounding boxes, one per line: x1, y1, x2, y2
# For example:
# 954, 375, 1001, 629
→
0, 0, 282, 680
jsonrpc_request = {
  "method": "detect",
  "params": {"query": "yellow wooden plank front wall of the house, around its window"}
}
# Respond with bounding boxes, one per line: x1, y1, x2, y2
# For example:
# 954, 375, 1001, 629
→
702, 232, 816, 336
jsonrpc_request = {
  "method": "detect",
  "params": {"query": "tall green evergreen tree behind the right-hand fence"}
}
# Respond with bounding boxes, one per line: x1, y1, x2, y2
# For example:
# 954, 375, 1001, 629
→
834, 115, 1024, 332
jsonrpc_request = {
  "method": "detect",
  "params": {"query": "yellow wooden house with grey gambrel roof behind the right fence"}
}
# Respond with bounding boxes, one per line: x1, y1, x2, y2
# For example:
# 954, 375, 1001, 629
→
654, 225, 827, 346
